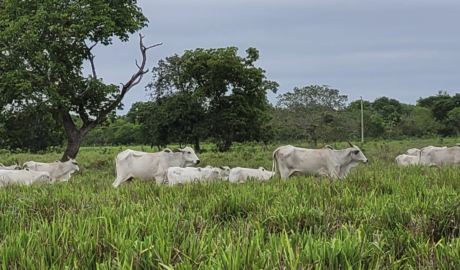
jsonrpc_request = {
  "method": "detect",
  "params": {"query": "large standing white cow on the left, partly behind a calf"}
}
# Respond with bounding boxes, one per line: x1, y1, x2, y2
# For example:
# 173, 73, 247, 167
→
113, 146, 200, 187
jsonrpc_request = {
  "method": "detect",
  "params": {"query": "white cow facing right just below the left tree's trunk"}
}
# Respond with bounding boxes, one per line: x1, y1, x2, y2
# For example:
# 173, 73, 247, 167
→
22, 157, 80, 183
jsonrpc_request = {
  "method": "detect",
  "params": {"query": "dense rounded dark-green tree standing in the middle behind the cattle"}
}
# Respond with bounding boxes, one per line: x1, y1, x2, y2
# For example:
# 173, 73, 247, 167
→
147, 47, 278, 151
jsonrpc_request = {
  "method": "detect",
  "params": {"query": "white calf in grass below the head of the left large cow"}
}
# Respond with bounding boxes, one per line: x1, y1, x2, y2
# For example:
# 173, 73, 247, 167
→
165, 167, 220, 186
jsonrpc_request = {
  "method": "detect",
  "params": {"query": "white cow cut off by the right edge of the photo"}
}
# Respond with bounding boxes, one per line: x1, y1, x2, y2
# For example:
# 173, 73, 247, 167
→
419, 144, 460, 166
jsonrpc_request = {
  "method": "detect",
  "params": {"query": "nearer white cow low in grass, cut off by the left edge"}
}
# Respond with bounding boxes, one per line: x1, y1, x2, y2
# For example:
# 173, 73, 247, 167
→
0, 169, 51, 187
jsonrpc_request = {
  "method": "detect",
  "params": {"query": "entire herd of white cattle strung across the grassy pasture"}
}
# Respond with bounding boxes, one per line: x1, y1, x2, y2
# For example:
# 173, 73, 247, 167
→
0, 142, 460, 187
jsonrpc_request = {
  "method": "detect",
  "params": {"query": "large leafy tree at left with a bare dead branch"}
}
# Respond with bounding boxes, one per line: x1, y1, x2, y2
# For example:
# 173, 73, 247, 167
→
0, 0, 161, 161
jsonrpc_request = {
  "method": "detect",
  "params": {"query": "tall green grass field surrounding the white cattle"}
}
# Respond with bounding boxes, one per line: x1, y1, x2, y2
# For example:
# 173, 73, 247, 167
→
0, 140, 460, 270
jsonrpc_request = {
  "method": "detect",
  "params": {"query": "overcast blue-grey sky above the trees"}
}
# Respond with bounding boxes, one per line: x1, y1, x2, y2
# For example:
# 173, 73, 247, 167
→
84, 0, 460, 114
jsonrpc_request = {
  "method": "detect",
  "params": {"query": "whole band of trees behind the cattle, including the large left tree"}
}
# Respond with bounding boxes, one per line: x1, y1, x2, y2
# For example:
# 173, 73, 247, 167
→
0, 0, 460, 157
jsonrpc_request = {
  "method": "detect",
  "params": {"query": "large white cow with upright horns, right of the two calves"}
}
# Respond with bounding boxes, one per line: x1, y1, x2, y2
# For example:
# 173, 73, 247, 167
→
272, 142, 368, 180
